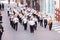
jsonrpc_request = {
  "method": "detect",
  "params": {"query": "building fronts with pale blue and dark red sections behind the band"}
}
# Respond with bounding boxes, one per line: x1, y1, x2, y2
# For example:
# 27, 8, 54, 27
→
0, 0, 60, 20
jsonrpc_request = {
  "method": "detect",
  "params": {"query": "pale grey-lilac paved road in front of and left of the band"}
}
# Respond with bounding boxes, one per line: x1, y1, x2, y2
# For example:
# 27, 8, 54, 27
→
2, 3, 60, 40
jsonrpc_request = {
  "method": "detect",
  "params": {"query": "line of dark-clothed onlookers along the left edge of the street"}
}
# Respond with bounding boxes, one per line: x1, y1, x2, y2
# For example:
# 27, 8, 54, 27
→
0, 3, 4, 40
